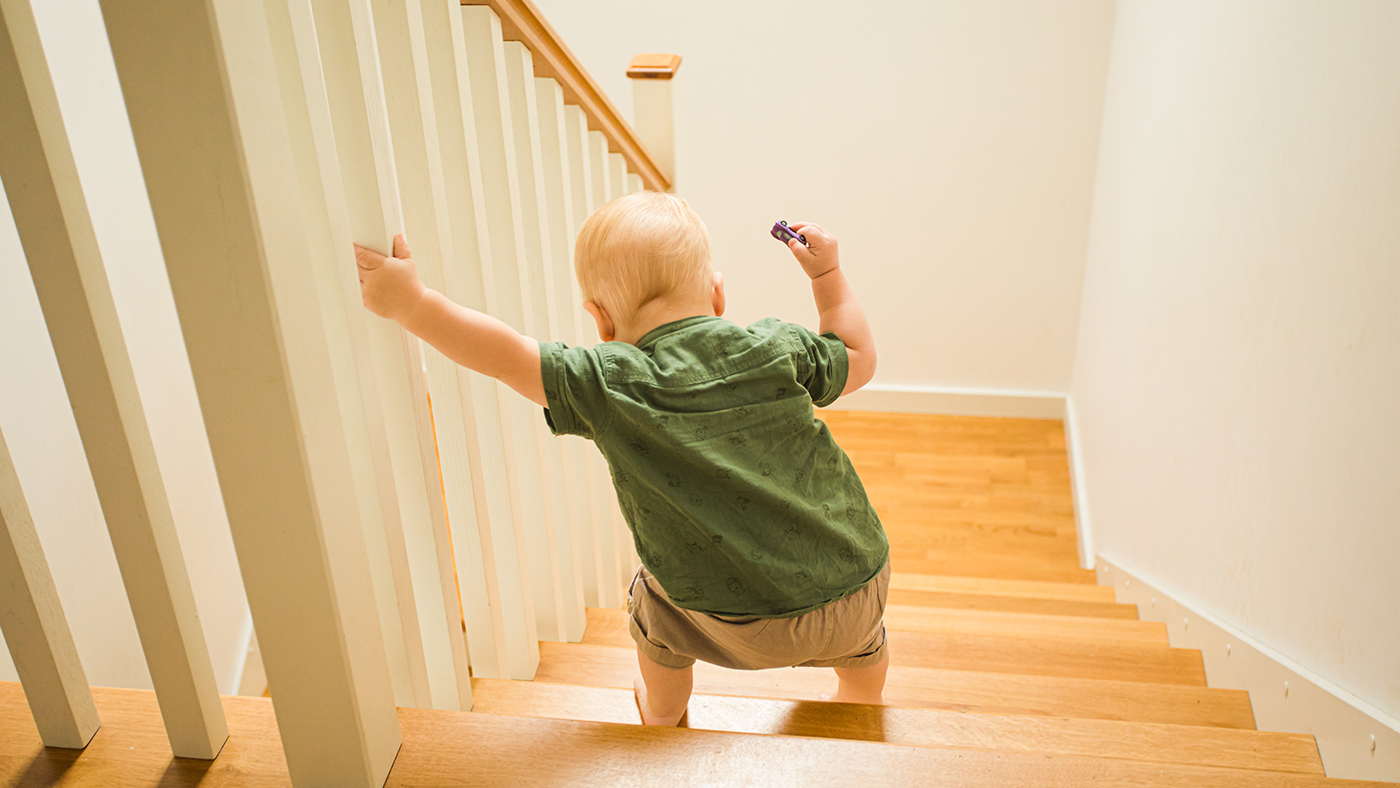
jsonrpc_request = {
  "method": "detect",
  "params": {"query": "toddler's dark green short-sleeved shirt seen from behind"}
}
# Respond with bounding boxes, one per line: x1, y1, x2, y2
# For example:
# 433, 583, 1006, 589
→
540, 316, 889, 617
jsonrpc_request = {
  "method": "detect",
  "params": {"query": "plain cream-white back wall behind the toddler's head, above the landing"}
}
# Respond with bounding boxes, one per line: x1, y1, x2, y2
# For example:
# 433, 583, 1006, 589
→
536, 0, 1113, 392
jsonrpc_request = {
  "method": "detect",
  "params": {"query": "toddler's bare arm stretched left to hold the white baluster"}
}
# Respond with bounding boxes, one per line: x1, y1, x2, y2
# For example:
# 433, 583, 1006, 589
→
354, 235, 545, 406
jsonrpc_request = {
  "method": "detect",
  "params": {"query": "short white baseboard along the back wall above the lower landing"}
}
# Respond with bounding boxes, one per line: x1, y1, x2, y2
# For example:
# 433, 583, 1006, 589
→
832, 385, 1065, 418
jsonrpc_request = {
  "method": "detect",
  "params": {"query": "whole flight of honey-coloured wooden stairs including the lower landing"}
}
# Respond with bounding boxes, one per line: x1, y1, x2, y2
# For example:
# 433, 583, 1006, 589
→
0, 413, 1380, 788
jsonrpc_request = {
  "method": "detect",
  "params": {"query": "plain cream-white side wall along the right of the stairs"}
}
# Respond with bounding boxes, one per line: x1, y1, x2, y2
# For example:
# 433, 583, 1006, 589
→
1071, 0, 1400, 718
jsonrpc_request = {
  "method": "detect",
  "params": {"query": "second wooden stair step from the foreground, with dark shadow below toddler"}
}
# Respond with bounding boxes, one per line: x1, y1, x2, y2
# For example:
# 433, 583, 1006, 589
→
472, 679, 1323, 774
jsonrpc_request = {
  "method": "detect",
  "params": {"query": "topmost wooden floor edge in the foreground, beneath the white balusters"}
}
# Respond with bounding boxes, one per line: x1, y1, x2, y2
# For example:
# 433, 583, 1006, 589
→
0, 683, 1387, 788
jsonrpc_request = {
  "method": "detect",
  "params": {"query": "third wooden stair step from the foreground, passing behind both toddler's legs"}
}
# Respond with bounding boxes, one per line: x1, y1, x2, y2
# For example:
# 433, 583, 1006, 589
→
535, 642, 1254, 729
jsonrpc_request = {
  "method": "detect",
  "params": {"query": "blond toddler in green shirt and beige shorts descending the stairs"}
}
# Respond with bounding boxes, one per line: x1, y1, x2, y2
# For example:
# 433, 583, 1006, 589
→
356, 192, 889, 725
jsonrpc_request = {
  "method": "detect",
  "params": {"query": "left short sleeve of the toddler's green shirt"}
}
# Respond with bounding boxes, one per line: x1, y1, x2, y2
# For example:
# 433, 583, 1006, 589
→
539, 342, 608, 439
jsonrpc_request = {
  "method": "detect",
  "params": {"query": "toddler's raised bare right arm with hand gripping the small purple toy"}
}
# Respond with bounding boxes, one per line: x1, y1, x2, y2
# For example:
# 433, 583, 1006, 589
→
788, 223, 875, 396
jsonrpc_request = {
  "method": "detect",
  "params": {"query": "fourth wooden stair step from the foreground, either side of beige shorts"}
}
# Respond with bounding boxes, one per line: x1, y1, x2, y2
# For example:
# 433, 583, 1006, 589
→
584, 607, 1205, 687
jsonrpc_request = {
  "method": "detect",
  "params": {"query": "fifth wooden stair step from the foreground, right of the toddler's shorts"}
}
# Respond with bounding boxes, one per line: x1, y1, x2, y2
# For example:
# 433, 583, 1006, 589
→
885, 605, 1169, 647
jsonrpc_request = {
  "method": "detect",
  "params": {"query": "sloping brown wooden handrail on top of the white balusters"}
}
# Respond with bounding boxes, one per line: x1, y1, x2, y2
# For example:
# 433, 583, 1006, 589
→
462, 0, 671, 192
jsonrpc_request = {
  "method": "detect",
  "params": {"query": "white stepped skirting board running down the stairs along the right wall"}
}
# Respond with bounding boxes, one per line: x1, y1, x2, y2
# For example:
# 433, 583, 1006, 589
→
1095, 554, 1400, 781
